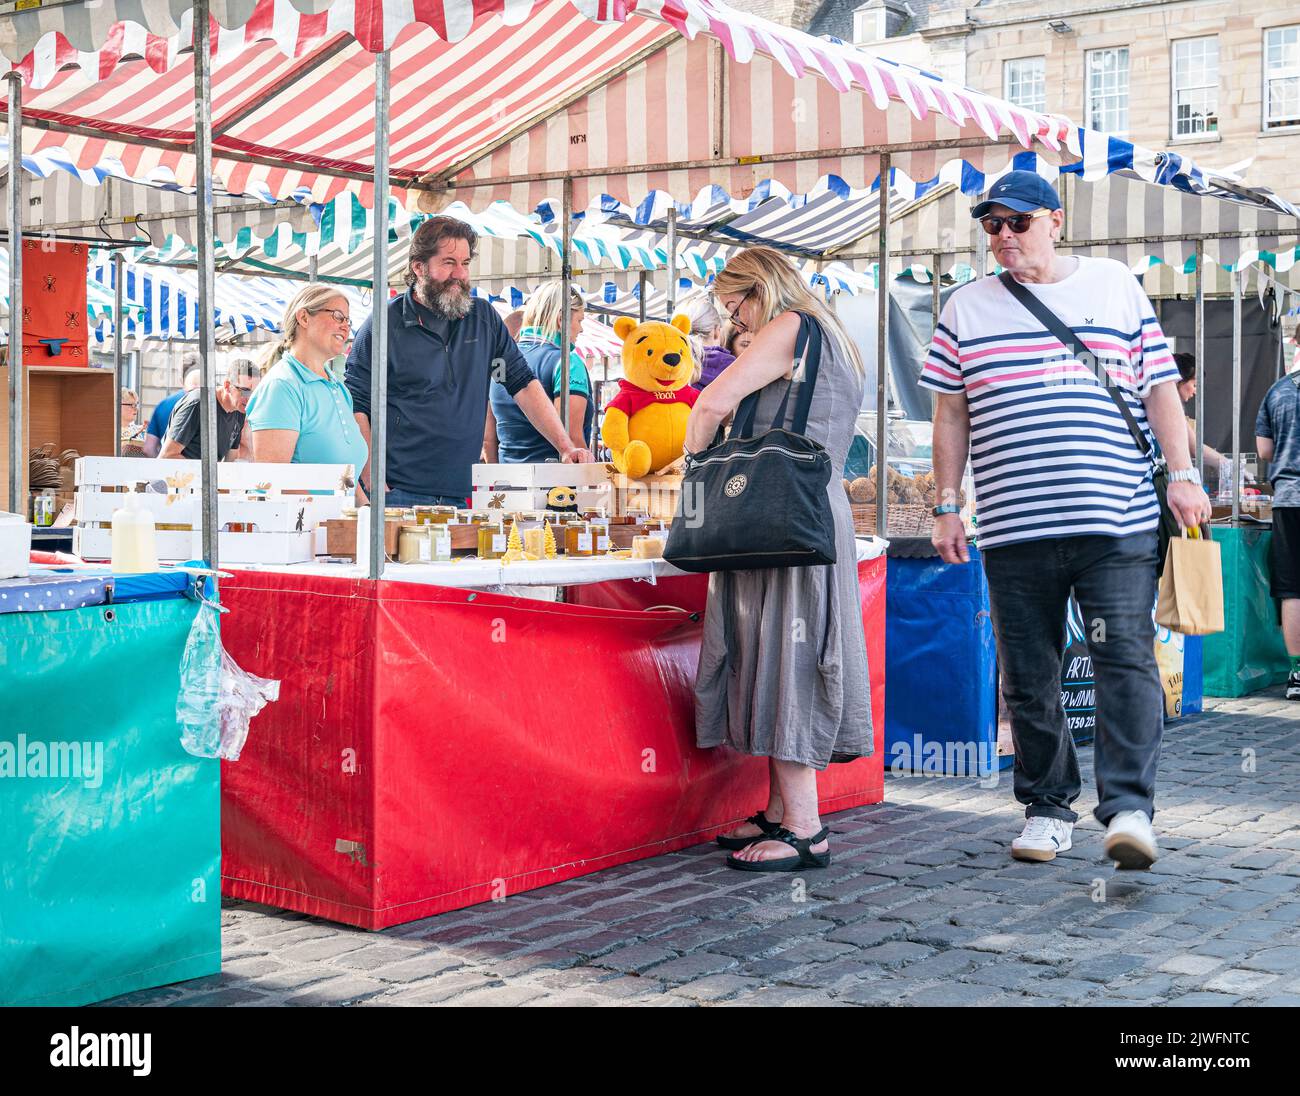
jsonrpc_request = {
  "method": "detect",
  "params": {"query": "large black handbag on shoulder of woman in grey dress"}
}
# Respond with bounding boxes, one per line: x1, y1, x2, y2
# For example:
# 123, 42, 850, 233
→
663, 313, 835, 572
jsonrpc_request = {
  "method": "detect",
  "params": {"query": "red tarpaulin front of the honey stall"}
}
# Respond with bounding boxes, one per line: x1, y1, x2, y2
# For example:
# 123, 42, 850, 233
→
222, 556, 885, 928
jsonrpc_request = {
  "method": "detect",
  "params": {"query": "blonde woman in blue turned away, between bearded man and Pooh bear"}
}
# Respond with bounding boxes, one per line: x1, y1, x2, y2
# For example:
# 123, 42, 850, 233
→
490, 282, 595, 464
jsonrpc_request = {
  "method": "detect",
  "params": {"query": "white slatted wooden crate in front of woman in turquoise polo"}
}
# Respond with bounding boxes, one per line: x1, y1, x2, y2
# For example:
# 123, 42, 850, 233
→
73, 456, 355, 563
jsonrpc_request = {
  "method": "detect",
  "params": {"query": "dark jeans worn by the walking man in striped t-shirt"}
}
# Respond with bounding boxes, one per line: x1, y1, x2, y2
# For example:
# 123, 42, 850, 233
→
983, 533, 1165, 824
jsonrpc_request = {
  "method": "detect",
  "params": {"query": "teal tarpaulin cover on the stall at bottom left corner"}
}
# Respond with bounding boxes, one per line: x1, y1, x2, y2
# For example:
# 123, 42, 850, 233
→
0, 597, 221, 1005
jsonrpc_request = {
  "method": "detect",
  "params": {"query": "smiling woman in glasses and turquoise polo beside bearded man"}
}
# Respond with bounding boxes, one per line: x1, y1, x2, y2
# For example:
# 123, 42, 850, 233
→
247, 285, 369, 476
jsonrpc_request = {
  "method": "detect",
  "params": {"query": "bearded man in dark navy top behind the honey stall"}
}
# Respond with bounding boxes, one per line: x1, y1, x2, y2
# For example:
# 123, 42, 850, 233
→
345, 217, 592, 506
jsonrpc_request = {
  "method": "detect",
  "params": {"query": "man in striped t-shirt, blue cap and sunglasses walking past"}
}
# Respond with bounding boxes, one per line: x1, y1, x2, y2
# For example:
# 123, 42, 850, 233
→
920, 172, 1210, 867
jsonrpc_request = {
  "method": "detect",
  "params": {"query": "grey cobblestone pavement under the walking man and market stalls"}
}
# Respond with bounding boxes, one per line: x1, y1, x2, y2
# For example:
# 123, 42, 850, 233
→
112, 688, 1300, 1006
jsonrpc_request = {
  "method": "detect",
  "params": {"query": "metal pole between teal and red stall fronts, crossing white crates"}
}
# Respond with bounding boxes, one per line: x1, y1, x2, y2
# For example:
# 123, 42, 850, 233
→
194, 0, 220, 571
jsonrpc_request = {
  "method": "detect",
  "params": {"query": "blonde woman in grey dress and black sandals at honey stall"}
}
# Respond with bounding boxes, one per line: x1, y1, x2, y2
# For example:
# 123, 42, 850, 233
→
686, 247, 872, 871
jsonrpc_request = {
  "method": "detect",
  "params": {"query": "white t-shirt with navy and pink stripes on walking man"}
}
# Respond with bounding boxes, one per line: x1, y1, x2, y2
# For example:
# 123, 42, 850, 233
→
920, 257, 1178, 549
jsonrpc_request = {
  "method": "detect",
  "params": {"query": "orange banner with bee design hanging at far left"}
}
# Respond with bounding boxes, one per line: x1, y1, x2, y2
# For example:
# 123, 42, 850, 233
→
22, 239, 90, 365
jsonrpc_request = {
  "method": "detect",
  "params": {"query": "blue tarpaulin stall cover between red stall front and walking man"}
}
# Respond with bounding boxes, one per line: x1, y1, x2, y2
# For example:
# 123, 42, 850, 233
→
885, 540, 998, 776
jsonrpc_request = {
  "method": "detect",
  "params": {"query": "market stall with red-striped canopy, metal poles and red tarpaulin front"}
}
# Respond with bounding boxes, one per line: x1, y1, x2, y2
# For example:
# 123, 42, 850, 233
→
4, 0, 1274, 941
